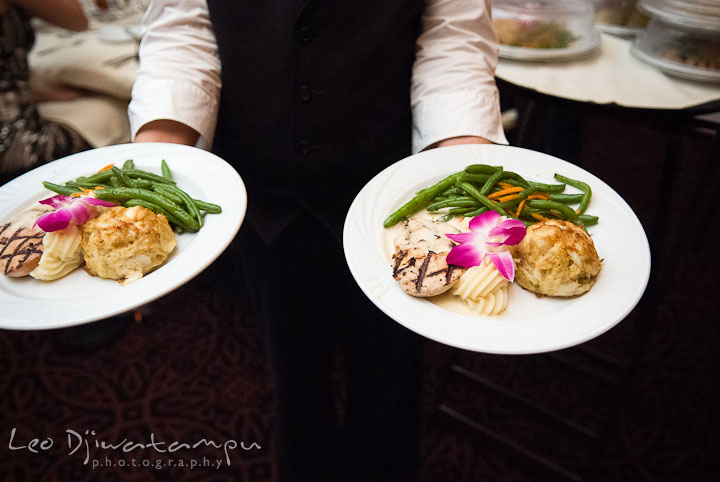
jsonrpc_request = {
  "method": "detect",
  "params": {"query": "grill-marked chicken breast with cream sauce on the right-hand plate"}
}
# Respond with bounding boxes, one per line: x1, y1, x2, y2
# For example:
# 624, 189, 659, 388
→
393, 219, 465, 297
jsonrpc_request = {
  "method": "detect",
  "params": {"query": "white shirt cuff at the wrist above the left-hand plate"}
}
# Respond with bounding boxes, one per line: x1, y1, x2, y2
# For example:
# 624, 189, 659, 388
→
128, 78, 218, 148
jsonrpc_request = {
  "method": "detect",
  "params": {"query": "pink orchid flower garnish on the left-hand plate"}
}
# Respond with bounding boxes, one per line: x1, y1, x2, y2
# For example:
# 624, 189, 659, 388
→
35, 194, 115, 233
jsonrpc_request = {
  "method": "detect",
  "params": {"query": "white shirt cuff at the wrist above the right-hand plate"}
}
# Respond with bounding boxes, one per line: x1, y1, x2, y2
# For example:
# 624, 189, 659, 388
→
413, 89, 508, 152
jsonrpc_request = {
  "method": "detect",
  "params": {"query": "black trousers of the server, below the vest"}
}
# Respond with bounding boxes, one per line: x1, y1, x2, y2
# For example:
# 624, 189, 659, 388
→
233, 211, 421, 482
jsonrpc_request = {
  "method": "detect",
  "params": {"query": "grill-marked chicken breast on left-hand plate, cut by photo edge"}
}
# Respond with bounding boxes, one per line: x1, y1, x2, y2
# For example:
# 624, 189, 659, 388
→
0, 204, 52, 277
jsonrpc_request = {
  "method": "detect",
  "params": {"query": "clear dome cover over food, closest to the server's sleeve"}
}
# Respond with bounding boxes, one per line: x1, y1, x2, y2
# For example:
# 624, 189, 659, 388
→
492, 0, 599, 60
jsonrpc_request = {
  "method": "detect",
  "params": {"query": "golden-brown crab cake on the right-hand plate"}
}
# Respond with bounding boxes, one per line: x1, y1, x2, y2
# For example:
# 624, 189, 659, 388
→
512, 219, 602, 296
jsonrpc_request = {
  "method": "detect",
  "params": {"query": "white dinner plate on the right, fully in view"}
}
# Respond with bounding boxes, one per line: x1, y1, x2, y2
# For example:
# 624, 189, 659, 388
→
343, 145, 650, 354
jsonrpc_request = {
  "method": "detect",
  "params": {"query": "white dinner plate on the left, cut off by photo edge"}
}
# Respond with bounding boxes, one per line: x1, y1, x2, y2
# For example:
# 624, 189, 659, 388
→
0, 143, 247, 330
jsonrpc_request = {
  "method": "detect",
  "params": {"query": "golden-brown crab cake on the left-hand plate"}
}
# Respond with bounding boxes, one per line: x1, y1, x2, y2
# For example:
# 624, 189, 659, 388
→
82, 206, 176, 284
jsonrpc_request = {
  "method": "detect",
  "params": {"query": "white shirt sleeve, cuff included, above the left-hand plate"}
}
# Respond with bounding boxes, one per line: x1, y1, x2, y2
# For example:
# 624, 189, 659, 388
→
128, 0, 221, 146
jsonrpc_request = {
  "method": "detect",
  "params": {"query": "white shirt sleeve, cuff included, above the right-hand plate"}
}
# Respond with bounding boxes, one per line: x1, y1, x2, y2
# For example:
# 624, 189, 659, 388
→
411, 0, 507, 152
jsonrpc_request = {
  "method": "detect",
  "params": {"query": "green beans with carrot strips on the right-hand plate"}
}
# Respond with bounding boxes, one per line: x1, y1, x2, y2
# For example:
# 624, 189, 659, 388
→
383, 164, 598, 228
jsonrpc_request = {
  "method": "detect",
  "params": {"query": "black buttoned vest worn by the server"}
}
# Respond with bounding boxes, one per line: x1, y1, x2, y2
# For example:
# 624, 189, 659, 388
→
208, 0, 423, 238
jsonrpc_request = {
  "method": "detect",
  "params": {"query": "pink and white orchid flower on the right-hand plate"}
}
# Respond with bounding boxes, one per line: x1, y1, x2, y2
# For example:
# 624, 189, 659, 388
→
445, 211, 525, 281
